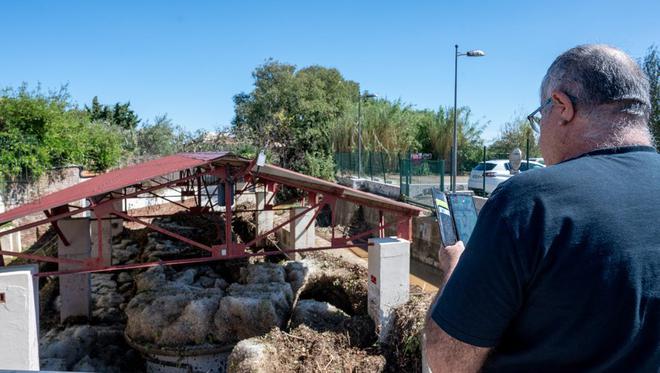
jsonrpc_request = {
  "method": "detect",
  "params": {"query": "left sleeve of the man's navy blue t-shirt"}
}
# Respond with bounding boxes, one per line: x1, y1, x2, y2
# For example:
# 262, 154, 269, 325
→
431, 190, 524, 347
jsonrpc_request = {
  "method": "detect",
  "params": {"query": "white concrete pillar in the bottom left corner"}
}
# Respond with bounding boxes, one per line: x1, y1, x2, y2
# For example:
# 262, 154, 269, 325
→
0, 265, 39, 370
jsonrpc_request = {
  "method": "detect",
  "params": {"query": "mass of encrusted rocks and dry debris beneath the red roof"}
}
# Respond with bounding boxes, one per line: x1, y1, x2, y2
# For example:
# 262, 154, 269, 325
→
29, 214, 428, 372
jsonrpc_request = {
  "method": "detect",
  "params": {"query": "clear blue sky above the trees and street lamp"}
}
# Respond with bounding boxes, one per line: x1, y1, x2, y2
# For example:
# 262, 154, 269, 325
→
0, 0, 660, 139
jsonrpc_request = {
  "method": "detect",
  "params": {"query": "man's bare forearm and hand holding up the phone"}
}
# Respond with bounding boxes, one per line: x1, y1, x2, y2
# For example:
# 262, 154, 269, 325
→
422, 241, 491, 373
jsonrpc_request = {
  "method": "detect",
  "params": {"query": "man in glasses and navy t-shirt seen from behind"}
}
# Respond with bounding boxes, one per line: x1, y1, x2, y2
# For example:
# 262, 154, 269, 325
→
425, 45, 660, 373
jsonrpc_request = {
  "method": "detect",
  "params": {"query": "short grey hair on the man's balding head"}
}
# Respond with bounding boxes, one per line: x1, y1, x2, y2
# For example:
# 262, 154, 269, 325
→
541, 44, 651, 135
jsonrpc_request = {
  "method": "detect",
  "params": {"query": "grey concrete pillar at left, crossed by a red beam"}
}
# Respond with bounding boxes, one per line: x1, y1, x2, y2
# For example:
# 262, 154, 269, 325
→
57, 218, 92, 321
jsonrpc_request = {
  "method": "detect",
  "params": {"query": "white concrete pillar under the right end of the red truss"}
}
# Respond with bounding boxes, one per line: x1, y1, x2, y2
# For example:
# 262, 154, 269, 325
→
367, 237, 410, 342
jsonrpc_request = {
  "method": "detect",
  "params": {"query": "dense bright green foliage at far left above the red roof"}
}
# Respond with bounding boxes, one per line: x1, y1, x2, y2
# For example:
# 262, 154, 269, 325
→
0, 85, 122, 180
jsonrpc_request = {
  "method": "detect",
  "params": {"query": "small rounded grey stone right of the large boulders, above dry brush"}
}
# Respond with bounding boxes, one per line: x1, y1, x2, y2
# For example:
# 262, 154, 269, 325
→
291, 299, 350, 332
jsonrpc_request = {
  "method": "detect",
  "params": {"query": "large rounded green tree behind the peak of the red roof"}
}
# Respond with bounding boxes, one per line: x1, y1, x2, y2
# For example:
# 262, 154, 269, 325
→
232, 60, 358, 179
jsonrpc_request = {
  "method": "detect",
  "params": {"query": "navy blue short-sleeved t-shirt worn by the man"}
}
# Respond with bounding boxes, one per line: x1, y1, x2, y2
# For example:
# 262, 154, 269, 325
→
432, 146, 660, 372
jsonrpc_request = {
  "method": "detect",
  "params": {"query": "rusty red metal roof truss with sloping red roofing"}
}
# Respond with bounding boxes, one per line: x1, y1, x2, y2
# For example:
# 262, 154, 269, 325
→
0, 153, 422, 276
